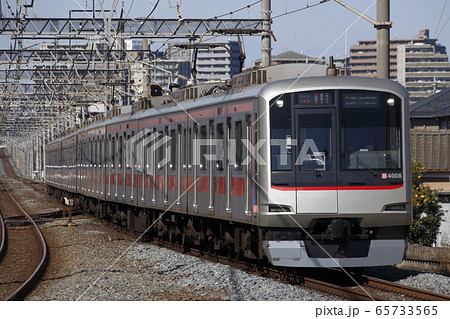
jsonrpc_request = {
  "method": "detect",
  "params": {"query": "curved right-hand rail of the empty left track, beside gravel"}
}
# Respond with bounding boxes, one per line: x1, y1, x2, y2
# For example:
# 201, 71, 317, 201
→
0, 179, 49, 301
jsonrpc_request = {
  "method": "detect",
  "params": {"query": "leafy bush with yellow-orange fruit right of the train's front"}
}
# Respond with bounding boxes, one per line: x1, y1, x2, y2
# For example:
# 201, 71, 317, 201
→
410, 161, 444, 246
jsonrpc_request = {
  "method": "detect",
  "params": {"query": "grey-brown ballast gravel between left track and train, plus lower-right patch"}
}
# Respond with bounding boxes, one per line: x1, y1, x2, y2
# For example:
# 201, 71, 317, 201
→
26, 216, 450, 301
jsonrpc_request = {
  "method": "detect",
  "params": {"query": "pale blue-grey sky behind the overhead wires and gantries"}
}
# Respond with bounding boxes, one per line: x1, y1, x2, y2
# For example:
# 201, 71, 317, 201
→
0, 0, 450, 67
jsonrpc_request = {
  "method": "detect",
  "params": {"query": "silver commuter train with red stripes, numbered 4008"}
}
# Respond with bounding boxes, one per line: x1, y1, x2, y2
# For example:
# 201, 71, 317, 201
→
45, 64, 412, 269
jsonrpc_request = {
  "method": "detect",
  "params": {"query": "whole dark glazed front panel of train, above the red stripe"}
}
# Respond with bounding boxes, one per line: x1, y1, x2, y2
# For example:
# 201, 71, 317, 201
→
270, 90, 403, 187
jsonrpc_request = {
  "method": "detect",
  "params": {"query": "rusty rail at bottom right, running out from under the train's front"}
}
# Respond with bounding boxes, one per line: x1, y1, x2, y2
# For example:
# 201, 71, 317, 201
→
363, 276, 450, 301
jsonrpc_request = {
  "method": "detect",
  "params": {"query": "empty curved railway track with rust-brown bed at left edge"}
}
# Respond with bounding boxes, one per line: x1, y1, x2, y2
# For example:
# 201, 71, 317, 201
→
0, 177, 48, 300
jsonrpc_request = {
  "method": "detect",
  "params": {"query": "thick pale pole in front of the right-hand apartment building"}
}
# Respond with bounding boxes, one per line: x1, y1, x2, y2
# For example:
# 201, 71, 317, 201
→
376, 0, 392, 79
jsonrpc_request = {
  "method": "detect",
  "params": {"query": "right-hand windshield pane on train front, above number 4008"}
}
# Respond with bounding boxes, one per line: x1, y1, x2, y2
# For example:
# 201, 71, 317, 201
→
340, 90, 401, 170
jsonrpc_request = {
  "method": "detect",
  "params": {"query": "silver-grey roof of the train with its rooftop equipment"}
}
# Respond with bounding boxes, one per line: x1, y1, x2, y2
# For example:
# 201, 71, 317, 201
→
49, 64, 408, 142
